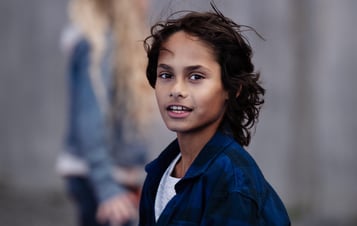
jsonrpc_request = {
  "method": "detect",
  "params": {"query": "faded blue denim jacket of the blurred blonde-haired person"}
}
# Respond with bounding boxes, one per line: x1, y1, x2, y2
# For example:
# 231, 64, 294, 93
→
66, 35, 146, 202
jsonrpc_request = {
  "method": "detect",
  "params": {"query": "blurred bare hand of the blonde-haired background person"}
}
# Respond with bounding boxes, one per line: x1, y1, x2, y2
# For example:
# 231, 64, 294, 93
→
97, 192, 138, 226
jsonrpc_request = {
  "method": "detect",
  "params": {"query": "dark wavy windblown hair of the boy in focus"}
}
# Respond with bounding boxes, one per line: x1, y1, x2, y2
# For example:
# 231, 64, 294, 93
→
144, 3, 265, 146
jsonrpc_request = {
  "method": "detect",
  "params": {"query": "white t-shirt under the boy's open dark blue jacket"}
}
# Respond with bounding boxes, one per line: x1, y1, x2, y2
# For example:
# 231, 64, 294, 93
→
155, 154, 181, 221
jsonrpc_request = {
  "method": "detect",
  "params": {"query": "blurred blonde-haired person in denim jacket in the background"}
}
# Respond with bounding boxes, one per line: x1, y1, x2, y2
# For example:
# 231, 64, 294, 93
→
56, 0, 153, 226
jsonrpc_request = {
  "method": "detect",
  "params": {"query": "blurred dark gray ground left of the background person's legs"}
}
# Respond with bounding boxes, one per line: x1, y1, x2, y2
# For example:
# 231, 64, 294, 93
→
0, 185, 75, 226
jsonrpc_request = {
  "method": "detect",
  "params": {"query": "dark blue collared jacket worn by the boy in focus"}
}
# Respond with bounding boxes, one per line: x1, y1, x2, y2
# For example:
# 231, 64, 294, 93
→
139, 132, 290, 226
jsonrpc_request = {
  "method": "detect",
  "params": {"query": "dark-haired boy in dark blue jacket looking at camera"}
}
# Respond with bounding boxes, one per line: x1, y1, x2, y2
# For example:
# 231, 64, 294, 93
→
139, 5, 290, 226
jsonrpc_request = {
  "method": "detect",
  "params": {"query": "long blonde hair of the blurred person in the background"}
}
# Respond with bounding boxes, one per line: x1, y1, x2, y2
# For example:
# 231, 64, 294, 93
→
69, 0, 154, 138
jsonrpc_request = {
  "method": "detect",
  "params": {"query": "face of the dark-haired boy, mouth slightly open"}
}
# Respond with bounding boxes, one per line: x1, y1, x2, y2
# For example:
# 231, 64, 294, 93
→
155, 31, 228, 136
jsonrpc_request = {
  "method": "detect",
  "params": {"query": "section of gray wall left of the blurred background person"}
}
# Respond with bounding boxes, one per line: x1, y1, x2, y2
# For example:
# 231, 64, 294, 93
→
0, 0, 66, 189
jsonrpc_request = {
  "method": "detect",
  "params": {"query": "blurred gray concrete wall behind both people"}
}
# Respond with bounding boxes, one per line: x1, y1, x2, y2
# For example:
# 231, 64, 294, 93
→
0, 0, 357, 225
